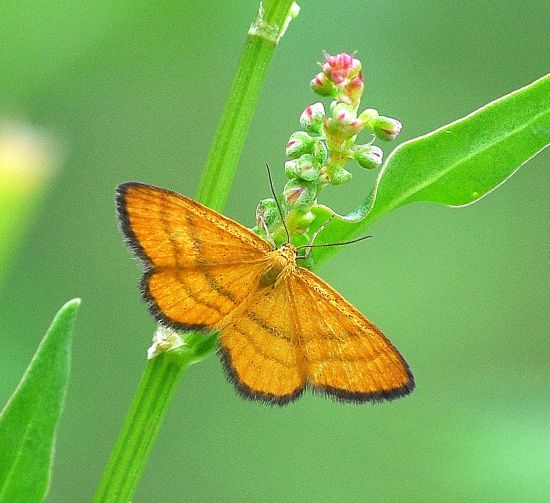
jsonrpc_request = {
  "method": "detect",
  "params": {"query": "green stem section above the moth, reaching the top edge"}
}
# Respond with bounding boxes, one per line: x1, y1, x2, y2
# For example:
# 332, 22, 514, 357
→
197, 0, 300, 211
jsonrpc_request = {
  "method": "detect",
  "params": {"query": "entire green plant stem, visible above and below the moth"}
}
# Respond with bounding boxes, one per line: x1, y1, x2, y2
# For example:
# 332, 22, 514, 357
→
93, 0, 293, 503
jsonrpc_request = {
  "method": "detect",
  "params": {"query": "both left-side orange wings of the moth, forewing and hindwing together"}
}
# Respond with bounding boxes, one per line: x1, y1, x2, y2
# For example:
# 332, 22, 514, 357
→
116, 182, 271, 329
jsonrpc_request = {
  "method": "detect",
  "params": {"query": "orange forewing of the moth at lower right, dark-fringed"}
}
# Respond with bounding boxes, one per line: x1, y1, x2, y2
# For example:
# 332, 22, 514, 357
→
289, 267, 414, 403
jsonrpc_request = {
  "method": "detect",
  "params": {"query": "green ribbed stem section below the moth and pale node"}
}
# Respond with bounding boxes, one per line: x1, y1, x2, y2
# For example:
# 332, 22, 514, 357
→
93, 351, 190, 503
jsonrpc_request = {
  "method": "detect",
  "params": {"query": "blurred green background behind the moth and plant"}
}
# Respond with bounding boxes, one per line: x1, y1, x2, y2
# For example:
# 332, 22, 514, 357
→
0, 0, 550, 503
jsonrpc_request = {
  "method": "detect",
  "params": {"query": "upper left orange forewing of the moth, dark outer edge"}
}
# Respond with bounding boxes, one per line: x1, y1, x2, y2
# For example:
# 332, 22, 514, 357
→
116, 182, 271, 268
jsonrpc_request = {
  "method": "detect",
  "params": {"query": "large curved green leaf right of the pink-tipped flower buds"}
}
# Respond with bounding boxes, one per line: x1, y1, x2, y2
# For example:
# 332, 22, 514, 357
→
312, 74, 550, 266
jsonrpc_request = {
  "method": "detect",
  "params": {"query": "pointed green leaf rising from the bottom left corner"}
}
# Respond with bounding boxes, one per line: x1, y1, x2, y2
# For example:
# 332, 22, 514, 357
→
0, 299, 80, 503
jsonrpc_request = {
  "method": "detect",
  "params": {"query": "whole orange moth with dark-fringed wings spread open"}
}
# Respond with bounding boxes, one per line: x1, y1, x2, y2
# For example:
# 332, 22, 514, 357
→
116, 182, 414, 405
